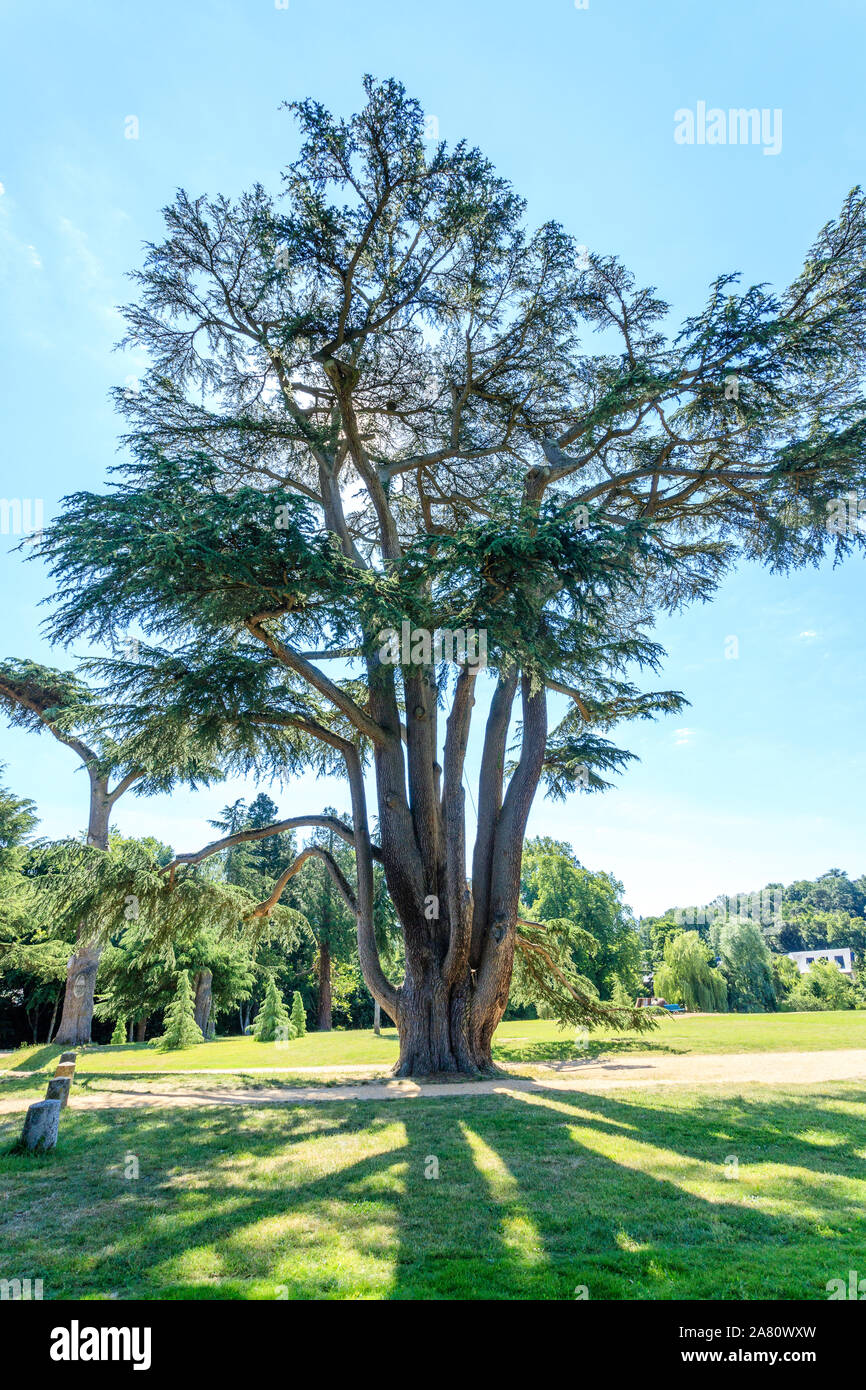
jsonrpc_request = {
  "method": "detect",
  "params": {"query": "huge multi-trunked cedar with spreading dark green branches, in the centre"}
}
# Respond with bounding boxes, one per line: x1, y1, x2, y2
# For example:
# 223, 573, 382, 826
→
39, 79, 866, 1073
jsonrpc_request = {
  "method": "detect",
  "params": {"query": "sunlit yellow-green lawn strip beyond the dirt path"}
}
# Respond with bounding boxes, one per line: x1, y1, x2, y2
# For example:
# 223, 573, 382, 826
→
0, 1009, 866, 1079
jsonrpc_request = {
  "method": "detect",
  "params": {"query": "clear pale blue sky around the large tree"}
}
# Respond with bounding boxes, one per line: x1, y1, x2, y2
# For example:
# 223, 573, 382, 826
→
0, 0, 866, 913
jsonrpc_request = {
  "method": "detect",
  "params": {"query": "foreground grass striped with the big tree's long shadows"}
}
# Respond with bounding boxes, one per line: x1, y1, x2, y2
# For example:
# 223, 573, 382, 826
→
0, 1083, 866, 1300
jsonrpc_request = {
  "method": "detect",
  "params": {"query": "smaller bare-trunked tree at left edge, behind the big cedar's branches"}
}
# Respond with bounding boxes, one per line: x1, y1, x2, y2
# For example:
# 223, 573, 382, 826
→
0, 659, 217, 1045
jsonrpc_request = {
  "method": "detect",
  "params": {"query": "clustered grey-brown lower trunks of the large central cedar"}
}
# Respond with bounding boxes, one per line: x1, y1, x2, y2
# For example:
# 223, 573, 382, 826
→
367, 670, 546, 1076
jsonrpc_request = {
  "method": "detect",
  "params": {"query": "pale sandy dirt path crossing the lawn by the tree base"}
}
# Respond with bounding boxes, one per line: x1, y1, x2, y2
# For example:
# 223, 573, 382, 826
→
0, 1048, 866, 1112
